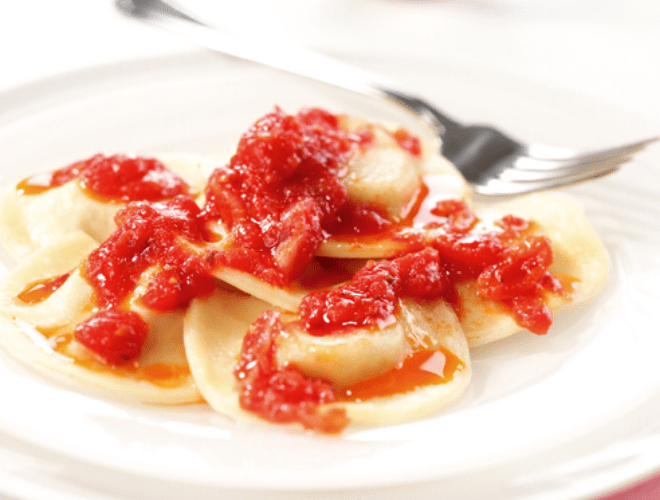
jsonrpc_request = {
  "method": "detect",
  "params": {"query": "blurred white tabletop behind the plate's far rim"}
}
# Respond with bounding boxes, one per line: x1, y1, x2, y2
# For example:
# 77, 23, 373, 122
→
5, 0, 660, 119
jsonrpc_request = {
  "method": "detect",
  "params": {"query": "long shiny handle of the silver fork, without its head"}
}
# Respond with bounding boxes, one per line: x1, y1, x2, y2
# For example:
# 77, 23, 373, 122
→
116, 0, 463, 140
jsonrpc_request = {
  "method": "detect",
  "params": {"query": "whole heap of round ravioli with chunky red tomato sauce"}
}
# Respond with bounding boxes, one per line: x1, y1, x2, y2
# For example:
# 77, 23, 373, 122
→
0, 108, 608, 433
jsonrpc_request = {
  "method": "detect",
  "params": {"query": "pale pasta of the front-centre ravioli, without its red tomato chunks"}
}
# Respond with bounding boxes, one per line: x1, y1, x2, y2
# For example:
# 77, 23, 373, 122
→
184, 289, 471, 425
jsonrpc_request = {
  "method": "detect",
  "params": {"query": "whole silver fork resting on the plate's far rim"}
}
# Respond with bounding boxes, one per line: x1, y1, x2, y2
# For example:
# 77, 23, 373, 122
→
116, 0, 660, 196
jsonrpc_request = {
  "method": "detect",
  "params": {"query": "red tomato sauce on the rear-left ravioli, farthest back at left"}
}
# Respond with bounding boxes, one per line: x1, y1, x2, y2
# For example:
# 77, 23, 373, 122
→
17, 154, 188, 201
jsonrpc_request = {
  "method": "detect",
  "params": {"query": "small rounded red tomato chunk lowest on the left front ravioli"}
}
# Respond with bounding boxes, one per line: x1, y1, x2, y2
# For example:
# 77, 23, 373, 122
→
74, 309, 149, 365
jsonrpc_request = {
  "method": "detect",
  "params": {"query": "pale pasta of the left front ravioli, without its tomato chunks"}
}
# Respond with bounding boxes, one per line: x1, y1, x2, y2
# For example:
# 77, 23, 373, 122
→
0, 232, 201, 404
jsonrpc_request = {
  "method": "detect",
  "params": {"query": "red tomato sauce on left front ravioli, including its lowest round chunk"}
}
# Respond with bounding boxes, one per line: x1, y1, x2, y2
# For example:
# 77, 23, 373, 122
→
75, 195, 215, 364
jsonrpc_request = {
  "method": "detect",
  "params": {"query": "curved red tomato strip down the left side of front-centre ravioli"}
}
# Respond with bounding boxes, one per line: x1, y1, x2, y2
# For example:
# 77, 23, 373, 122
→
234, 311, 348, 433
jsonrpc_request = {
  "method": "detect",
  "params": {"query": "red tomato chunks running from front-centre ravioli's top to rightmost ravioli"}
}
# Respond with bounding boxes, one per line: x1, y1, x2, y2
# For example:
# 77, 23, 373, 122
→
299, 200, 561, 335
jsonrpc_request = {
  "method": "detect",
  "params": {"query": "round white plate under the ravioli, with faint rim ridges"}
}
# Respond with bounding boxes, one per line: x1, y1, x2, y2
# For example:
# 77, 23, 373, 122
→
0, 53, 660, 500
